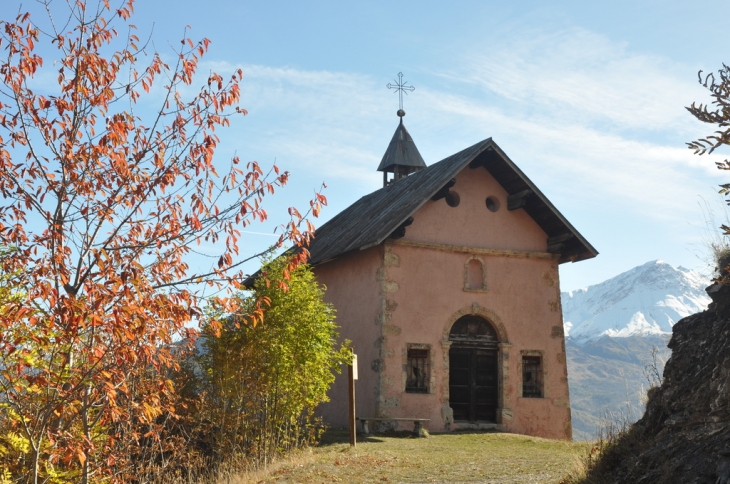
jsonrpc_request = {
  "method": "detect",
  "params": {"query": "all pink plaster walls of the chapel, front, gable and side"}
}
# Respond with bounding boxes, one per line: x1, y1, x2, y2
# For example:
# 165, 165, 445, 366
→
315, 168, 571, 439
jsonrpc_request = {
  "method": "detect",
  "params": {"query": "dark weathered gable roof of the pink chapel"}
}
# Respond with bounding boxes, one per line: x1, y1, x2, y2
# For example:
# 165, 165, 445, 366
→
309, 136, 598, 265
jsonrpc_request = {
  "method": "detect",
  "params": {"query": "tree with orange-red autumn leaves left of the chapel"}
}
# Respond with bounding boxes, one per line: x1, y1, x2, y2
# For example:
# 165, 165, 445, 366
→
0, 0, 324, 483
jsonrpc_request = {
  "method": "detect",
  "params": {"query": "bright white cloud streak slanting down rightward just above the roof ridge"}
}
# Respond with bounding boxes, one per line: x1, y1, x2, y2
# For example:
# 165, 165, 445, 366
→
410, 88, 722, 220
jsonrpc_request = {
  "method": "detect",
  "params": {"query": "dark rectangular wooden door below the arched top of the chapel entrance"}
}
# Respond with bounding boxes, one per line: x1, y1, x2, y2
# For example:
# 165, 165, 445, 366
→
449, 347, 498, 422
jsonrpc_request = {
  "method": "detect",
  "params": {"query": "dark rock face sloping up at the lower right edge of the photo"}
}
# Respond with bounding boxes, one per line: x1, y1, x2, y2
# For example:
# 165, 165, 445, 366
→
588, 285, 730, 484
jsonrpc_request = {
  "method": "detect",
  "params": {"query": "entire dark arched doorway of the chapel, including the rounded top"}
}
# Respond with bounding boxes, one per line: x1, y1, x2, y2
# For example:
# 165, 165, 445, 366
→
449, 315, 499, 422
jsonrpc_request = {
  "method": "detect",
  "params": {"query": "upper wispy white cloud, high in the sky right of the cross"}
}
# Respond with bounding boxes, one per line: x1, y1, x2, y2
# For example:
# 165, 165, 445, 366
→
454, 28, 698, 134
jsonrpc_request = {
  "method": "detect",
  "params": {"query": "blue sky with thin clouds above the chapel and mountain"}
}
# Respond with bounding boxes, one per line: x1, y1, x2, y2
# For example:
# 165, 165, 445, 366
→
5, 0, 730, 290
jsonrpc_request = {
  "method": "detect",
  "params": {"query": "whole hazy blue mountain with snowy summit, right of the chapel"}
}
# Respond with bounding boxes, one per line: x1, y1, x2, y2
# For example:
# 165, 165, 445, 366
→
561, 261, 710, 440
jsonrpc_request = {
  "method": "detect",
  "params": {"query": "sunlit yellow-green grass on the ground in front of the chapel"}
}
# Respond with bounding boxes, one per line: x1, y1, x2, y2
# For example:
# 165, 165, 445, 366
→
211, 431, 589, 484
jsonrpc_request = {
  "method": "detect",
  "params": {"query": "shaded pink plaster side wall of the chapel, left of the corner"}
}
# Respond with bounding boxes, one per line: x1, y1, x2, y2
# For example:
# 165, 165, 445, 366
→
314, 247, 383, 427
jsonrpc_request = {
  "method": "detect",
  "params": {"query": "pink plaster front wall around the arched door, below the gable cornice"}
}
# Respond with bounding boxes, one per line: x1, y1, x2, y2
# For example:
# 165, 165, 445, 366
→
383, 248, 570, 439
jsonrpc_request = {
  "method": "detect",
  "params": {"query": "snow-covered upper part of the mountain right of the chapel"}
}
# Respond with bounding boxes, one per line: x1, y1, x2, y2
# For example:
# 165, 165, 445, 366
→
561, 260, 710, 344
